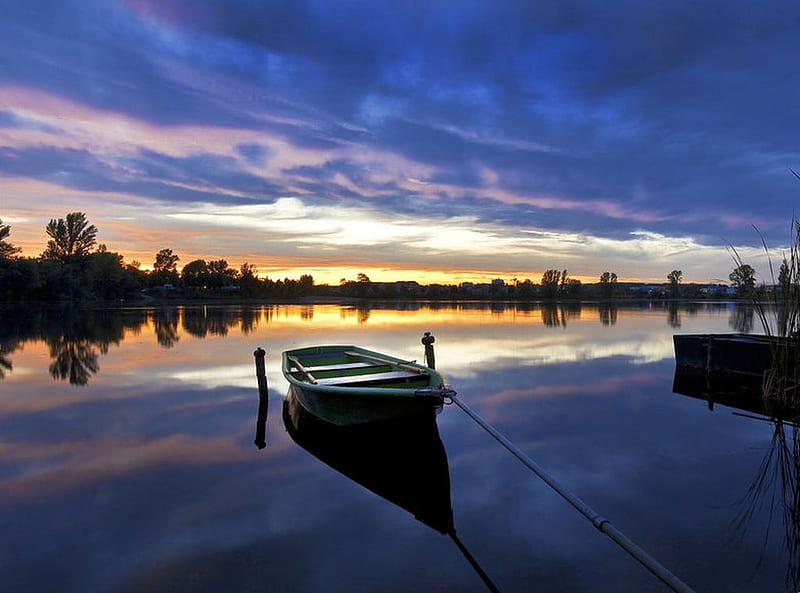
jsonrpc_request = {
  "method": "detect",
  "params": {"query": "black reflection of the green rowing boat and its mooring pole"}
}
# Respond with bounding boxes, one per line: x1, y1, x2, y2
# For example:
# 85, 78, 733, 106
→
283, 390, 498, 591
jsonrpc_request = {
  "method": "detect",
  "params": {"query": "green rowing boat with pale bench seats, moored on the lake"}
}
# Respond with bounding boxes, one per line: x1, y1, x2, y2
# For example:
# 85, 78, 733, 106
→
281, 346, 455, 425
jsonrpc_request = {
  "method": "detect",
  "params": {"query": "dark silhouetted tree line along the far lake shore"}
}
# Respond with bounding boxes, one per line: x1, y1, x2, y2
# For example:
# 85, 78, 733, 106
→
0, 212, 756, 301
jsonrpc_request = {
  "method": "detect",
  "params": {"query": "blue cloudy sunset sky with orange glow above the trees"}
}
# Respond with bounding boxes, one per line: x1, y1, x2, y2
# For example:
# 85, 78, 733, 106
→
0, 0, 800, 284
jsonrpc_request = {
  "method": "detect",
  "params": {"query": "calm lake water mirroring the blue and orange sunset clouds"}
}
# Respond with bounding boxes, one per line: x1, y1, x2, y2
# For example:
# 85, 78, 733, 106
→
0, 305, 797, 593
